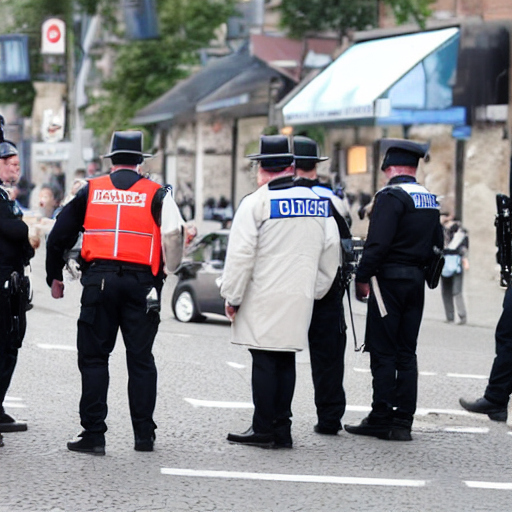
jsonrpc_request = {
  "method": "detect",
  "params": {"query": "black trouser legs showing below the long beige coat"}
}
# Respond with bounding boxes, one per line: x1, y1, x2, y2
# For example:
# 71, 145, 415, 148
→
249, 349, 295, 438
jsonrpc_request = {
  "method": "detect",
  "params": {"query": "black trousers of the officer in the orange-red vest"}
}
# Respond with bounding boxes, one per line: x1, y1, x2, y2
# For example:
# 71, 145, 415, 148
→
77, 262, 161, 438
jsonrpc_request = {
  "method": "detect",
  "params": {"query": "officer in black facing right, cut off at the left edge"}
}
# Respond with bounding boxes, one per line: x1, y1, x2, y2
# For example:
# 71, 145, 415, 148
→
0, 128, 34, 445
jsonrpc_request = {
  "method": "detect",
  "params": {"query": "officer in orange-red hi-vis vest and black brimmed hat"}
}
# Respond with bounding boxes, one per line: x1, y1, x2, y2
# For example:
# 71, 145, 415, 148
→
46, 131, 184, 455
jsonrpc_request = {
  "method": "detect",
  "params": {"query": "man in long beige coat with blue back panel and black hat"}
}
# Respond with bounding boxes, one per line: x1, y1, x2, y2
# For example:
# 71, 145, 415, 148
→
221, 135, 340, 448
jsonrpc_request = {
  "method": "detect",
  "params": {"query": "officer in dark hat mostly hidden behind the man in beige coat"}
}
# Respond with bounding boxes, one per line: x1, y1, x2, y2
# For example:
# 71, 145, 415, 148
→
293, 135, 351, 435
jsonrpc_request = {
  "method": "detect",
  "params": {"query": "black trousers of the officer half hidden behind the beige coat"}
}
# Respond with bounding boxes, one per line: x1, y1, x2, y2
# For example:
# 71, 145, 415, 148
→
308, 271, 347, 429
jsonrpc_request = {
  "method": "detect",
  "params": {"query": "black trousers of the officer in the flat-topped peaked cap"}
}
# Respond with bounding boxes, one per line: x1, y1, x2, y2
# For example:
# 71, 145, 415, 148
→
365, 266, 425, 428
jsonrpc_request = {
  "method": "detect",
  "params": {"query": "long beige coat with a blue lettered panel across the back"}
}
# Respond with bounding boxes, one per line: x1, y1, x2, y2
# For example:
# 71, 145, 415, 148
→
221, 185, 340, 352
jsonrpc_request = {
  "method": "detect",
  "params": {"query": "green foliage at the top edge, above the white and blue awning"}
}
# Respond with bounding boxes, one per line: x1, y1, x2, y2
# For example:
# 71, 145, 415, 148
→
279, 0, 435, 40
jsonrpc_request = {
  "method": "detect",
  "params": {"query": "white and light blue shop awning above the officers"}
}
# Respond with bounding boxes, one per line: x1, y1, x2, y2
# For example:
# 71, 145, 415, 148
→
283, 27, 464, 125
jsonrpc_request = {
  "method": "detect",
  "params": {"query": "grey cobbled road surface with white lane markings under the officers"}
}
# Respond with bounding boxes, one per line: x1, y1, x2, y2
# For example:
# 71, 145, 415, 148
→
0, 250, 512, 512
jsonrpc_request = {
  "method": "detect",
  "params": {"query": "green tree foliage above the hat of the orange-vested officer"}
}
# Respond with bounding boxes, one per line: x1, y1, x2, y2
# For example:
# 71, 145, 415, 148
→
87, 0, 238, 140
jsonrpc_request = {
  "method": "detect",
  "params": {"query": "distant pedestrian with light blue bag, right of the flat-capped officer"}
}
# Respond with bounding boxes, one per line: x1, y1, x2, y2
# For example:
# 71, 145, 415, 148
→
441, 213, 469, 325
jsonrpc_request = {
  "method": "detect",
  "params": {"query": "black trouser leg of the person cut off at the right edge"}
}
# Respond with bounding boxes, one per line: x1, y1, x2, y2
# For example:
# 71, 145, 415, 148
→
485, 287, 512, 405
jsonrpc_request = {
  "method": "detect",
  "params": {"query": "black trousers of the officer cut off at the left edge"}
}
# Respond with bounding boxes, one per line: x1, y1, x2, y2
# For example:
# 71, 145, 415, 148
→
0, 267, 27, 416
